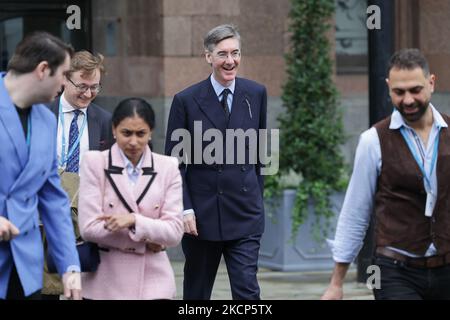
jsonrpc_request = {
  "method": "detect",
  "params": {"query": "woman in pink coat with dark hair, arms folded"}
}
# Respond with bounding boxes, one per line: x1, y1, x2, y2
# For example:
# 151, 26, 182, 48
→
78, 98, 183, 299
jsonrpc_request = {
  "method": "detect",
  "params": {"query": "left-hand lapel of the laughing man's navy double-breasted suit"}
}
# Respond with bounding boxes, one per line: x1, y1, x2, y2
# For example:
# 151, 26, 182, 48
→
194, 78, 227, 132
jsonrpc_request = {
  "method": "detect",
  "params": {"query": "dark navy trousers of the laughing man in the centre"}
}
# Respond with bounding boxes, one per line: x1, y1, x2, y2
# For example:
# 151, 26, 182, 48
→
181, 235, 261, 300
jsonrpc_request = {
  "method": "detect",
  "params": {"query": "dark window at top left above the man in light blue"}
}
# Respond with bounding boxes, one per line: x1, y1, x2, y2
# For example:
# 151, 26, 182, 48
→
0, 0, 91, 71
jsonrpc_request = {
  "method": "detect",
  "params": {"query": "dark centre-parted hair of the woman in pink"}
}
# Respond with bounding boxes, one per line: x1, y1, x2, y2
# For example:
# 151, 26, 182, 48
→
112, 98, 155, 130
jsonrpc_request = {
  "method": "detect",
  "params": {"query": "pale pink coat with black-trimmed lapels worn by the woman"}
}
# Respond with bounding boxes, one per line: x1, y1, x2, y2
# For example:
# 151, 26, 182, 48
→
78, 144, 183, 299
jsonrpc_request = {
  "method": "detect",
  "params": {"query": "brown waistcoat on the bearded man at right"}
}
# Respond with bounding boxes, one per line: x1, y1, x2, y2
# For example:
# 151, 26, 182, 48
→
375, 115, 450, 255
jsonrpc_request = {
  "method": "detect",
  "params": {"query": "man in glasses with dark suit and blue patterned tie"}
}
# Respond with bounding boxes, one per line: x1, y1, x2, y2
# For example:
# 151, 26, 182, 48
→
42, 51, 113, 299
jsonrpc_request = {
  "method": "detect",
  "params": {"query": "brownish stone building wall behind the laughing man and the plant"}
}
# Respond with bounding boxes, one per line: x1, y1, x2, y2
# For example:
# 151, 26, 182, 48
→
88, 0, 450, 165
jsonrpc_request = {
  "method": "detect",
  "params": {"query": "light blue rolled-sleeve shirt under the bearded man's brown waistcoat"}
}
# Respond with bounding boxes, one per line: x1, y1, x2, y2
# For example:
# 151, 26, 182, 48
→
329, 103, 447, 263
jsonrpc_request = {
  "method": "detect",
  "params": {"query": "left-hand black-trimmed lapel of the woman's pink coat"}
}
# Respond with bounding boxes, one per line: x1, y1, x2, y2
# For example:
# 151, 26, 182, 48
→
105, 144, 137, 212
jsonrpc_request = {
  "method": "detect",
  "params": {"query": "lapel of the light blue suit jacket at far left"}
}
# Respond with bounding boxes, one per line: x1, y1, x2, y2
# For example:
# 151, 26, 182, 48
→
0, 75, 28, 168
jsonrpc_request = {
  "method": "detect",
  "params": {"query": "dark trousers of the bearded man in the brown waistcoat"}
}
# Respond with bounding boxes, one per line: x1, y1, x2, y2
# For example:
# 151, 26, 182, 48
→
373, 256, 450, 300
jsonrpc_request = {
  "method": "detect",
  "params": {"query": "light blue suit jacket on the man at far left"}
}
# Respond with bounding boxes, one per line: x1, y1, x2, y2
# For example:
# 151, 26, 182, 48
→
0, 74, 79, 298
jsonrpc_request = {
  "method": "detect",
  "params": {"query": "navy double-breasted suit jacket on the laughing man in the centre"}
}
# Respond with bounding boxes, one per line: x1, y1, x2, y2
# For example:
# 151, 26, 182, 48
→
166, 78, 267, 241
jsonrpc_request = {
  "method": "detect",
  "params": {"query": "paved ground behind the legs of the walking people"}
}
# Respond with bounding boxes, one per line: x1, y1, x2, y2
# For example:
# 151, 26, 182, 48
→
172, 261, 373, 300
